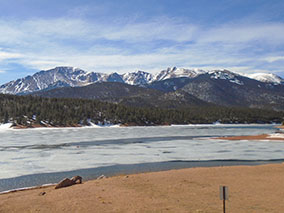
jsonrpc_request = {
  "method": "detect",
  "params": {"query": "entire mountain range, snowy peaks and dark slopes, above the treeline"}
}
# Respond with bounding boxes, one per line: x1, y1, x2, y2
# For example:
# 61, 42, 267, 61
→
0, 67, 284, 110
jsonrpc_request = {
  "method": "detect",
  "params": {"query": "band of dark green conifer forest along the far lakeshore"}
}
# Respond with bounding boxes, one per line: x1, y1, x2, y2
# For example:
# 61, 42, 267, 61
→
0, 94, 284, 126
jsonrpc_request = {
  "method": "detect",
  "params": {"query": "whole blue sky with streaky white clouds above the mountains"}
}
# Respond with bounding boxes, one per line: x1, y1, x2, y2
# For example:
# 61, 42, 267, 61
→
0, 0, 284, 84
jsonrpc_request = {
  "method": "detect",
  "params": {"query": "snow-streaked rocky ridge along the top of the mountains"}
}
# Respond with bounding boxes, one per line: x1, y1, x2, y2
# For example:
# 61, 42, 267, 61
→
0, 67, 284, 94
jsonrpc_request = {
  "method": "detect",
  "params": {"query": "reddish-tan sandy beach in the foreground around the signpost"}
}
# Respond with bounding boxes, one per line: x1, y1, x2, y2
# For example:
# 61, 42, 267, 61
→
0, 164, 284, 213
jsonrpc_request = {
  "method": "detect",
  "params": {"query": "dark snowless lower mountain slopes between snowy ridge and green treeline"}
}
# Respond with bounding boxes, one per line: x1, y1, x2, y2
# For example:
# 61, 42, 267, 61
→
33, 71, 284, 110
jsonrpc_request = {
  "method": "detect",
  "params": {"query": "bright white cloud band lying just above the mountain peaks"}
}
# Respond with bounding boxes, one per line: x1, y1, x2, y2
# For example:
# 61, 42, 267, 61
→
6, 36, 282, 73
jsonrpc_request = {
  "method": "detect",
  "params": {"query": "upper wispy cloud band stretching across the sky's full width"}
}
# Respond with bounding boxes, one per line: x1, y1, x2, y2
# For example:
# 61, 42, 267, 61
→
0, 17, 284, 45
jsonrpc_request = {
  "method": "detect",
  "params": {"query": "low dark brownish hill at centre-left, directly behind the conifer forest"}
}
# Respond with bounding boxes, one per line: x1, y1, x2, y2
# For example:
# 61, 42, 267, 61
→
32, 82, 212, 108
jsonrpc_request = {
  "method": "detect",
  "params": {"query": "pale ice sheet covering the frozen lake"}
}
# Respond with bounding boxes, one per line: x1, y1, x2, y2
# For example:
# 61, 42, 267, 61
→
0, 125, 284, 182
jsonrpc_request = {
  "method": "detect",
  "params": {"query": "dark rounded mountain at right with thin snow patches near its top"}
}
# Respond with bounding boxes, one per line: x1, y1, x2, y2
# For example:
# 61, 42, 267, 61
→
178, 72, 284, 110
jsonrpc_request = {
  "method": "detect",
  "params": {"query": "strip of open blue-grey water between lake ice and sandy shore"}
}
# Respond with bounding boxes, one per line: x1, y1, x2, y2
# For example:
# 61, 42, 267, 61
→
0, 159, 284, 194
